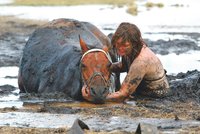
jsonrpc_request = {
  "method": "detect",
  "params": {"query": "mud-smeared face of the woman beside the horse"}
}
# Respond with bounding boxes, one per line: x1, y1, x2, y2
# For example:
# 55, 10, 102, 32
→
115, 38, 133, 56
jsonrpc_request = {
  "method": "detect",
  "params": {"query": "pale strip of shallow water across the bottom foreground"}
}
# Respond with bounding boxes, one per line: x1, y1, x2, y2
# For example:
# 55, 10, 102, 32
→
0, 112, 200, 132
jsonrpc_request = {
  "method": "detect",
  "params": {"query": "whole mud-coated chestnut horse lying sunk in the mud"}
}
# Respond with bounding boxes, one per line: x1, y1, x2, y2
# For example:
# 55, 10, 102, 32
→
18, 18, 119, 103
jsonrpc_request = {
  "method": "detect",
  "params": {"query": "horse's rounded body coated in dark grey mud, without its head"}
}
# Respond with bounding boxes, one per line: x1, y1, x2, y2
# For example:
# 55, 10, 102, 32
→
18, 19, 119, 102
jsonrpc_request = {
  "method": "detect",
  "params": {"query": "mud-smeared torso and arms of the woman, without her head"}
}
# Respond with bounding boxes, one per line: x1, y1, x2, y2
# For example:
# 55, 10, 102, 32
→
106, 47, 170, 102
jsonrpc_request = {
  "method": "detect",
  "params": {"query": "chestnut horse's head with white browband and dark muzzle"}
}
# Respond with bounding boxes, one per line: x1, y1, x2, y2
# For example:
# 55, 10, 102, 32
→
80, 35, 112, 103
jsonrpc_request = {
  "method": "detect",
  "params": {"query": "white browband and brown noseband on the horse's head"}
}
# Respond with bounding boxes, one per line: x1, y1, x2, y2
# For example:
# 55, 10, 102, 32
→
80, 48, 113, 92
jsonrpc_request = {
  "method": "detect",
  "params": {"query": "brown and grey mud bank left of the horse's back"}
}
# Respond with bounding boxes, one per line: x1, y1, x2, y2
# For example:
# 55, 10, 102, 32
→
0, 16, 44, 67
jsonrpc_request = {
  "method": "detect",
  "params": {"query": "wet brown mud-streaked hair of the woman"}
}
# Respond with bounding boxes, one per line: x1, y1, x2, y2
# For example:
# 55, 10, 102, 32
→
111, 22, 144, 58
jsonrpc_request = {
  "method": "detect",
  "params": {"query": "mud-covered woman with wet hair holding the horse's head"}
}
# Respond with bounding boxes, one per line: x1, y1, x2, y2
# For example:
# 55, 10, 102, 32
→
106, 23, 170, 102
